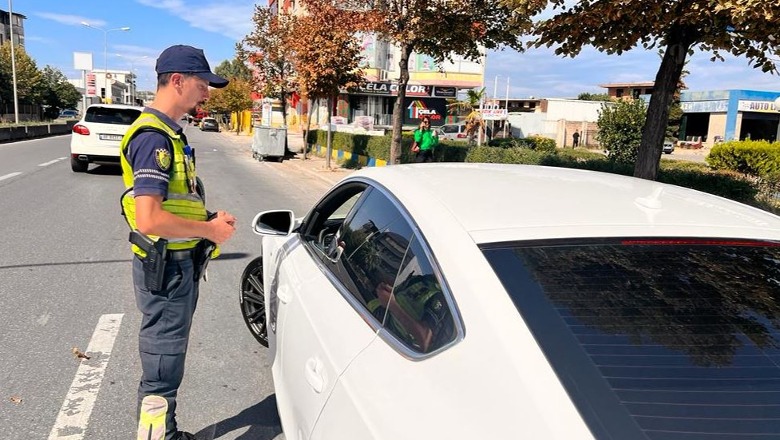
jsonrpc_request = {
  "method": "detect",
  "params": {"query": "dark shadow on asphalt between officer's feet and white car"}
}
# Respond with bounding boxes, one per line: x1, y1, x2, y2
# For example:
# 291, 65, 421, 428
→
195, 394, 282, 440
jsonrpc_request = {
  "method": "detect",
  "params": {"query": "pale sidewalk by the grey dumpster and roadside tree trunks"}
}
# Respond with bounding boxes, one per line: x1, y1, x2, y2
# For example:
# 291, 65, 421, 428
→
219, 131, 354, 185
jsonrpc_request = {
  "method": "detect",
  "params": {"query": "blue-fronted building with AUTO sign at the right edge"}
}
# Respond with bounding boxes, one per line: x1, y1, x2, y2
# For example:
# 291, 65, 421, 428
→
679, 90, 780, 147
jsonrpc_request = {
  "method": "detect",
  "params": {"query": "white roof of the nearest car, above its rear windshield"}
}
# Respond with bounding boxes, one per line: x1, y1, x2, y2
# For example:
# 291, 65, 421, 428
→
348, 163, 780, 243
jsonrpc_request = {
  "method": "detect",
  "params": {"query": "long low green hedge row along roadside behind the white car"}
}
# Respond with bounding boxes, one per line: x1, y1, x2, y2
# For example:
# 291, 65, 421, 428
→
308, 131, 780, 214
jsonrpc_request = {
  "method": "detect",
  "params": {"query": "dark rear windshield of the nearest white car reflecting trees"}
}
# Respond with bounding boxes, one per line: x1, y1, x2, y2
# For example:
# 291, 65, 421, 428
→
482, 239, 780, 440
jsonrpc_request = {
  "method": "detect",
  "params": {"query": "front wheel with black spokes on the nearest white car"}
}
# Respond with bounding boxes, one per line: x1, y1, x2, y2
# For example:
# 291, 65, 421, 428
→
240, 257, 268, 347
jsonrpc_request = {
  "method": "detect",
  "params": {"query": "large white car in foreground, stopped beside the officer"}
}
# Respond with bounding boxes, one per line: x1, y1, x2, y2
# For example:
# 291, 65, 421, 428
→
241, 164, 780, 440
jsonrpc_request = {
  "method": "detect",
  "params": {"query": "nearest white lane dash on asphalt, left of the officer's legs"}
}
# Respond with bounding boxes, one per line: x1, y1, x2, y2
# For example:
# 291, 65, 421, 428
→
49, 313, 124, 440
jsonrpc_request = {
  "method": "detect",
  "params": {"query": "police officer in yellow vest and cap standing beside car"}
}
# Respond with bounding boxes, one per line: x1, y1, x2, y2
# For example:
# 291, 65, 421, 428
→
120, 45, 236, 440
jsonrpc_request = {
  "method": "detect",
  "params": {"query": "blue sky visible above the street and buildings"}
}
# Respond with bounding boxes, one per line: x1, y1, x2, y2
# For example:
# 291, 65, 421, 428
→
13, 0, 780, 98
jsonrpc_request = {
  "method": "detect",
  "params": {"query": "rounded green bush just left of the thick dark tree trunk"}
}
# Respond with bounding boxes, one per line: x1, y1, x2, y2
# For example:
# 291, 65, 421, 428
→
597, 99, 647, 164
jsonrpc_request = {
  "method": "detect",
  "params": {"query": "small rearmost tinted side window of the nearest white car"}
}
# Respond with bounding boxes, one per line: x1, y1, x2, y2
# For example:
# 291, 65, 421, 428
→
383, 237, 456, 353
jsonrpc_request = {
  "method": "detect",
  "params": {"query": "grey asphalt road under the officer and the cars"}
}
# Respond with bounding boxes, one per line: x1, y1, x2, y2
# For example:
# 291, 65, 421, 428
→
0, 128, 330, 440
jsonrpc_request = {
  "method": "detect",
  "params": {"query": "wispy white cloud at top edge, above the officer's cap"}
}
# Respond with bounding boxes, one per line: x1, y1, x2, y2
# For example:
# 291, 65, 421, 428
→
136, 0, 255, 41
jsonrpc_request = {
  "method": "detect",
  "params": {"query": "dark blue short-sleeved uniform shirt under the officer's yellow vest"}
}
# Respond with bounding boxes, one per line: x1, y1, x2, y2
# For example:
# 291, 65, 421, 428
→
127, 107, 187, 199
